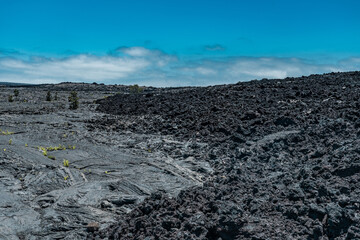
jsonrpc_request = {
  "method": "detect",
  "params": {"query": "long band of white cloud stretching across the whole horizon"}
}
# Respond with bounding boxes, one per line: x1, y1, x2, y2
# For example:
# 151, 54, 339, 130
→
0, 47, 360, 87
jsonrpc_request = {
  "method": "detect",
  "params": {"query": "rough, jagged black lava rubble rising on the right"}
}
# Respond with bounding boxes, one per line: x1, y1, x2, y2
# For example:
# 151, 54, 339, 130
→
88, 72, 360, 240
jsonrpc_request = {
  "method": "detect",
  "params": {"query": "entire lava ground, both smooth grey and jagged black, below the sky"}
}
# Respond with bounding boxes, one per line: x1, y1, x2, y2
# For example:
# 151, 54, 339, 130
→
0, 72, 360, 240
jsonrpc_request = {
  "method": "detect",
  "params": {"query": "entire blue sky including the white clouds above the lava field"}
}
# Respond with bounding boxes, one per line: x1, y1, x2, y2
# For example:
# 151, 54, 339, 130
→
0, 0, 360, 86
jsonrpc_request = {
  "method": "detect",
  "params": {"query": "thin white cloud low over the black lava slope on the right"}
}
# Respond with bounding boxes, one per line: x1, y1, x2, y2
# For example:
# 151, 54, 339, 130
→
175, 57, 360, 85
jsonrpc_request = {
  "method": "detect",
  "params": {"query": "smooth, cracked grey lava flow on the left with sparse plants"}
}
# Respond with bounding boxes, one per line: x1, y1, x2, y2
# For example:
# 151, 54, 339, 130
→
0, 84, 212, 239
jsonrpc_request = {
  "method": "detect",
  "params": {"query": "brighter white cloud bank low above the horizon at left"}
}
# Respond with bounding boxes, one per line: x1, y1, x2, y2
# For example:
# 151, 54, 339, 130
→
0, 55, 151, 82
